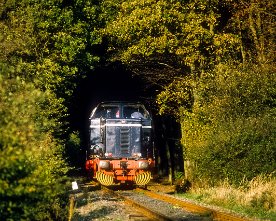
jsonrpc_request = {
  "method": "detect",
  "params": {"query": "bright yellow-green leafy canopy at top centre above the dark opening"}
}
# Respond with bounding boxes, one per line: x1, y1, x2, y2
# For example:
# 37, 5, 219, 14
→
105, 0, 216, 66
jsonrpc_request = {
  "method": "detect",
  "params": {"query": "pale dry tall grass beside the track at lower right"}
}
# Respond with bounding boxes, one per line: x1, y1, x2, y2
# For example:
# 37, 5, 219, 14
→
182, 176, 276, 220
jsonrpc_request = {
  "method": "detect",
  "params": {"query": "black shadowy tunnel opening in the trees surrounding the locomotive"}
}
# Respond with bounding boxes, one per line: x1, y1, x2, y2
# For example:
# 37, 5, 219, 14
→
67, 63, 184, 176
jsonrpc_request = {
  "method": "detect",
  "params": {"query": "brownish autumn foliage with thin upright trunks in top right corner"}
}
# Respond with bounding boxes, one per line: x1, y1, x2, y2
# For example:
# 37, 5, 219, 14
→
224, 0, 276, 65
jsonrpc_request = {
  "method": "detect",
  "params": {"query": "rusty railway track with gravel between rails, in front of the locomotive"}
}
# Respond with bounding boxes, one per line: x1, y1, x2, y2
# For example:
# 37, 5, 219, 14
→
71, 180, 264, 221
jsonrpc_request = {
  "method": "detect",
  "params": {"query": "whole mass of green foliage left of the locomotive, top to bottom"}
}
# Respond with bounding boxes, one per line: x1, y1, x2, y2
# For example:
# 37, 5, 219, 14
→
0, 0, 105, 220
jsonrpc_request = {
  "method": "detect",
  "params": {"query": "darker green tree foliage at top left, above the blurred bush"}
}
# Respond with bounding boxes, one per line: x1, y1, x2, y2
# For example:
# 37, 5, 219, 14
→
0, 0, 101, 99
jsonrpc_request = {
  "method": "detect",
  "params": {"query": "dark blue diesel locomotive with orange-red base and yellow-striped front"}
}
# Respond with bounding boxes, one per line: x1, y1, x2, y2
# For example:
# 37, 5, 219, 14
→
85, 101, 155, 186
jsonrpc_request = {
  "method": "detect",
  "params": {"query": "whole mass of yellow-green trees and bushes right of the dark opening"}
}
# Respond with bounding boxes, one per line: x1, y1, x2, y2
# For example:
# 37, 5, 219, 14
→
100, 0, 275, 186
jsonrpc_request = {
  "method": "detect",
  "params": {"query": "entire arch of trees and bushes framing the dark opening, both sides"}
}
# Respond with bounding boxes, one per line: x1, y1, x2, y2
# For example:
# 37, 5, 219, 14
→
0, 0, 276, 220
